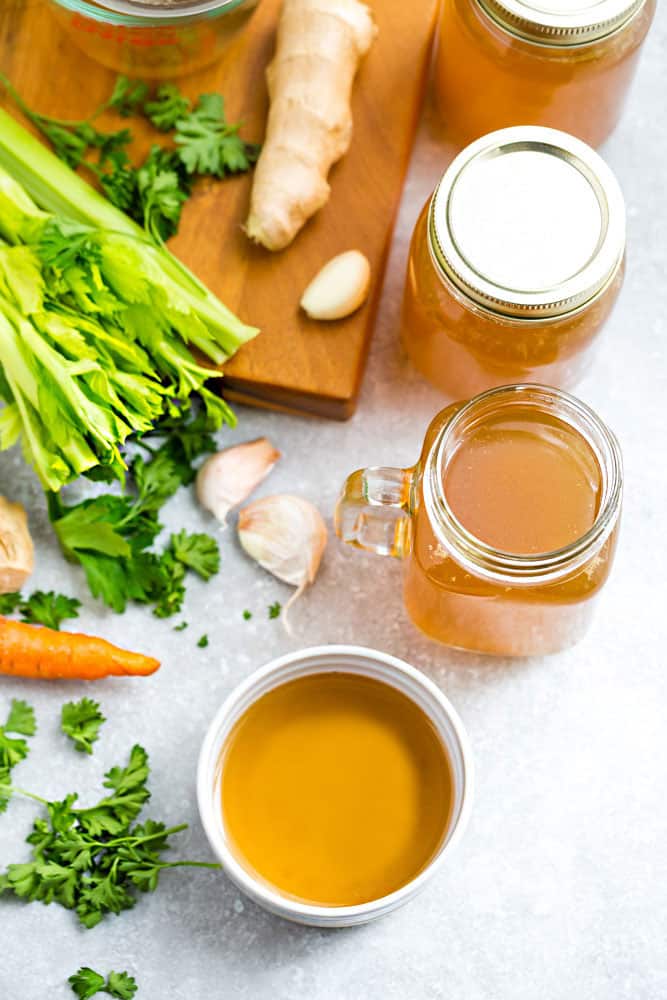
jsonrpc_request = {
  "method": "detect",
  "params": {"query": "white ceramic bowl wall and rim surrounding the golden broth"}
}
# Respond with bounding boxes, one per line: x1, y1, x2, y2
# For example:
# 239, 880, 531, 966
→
197, 646, 473, 927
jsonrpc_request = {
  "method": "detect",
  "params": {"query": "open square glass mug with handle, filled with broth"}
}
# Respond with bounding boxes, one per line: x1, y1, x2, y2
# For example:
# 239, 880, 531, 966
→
335, 385, 623, 656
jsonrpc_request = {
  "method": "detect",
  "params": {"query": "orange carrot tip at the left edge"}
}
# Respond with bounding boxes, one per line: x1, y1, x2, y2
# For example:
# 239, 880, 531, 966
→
0, 618, 160, 681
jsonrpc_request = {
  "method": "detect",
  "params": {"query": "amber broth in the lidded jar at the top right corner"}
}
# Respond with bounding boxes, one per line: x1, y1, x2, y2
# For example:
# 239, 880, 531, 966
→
434, 0, 655, 146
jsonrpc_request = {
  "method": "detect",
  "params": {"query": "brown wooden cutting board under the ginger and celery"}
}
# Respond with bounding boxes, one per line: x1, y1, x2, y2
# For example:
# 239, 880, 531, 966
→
0, 0, 438, 419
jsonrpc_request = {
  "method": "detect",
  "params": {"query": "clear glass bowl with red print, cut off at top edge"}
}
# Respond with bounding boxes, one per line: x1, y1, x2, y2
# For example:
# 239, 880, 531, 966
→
49, 0, 258, 79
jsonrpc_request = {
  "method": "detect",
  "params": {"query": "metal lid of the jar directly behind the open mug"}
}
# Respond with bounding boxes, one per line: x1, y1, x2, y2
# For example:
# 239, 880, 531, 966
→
428, 125, 625, 319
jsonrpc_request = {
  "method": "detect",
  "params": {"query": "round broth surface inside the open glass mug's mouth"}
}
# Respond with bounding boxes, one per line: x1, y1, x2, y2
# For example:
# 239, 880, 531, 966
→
444, 407, 601, 555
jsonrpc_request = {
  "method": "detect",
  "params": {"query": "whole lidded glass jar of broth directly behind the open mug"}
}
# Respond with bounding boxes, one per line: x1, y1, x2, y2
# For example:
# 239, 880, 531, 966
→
401, 126, 625, 399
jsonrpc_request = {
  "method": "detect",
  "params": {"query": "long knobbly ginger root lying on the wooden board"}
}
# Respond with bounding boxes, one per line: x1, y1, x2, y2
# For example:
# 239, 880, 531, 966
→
245, 0, 376, 250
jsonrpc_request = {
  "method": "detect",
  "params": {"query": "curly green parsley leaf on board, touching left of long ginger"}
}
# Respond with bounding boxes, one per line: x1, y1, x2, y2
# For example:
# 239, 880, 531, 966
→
174, 94, 259, 177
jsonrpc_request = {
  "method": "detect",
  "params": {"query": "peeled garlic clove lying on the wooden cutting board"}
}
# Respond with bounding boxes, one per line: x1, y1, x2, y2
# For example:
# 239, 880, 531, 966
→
301, 250, 371, 319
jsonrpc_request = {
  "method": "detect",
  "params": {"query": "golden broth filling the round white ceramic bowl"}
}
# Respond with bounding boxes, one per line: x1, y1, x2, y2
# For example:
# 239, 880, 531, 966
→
221, 672, 452, 906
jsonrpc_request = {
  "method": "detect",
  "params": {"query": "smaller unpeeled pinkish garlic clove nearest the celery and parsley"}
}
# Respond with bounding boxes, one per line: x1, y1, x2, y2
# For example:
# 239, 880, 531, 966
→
195, 438, 281, 525
